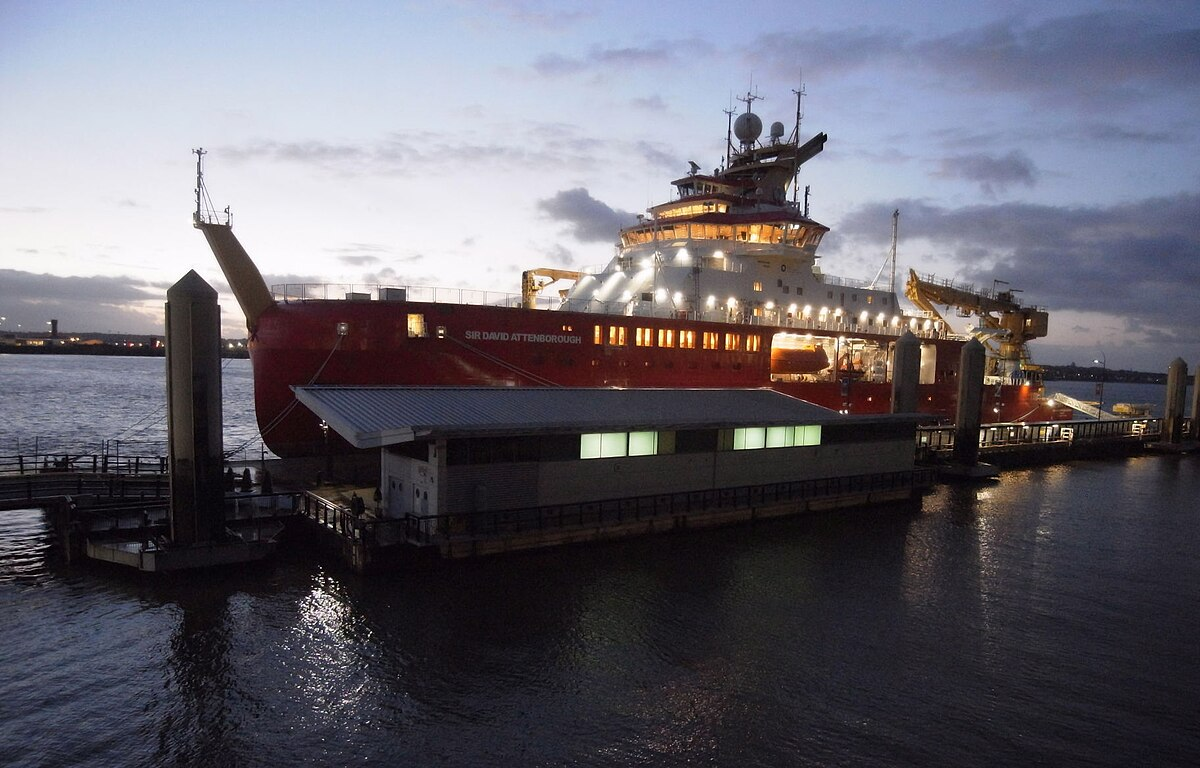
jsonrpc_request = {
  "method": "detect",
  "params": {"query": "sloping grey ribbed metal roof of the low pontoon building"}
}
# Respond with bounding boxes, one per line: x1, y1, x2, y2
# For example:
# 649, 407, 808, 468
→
293, 386, 859, 448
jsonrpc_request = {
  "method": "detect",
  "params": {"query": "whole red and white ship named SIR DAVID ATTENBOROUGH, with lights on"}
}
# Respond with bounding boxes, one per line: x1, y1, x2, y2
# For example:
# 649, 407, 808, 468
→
193, 94, 1070, 456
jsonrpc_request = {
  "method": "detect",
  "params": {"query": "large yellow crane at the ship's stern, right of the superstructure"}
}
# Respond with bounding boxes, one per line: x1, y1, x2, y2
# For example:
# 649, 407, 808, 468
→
905, 270, 1049, 379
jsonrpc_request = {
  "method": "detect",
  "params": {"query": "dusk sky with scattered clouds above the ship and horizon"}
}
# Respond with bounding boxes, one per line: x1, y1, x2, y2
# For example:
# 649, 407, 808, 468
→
0, 0, 1200, 371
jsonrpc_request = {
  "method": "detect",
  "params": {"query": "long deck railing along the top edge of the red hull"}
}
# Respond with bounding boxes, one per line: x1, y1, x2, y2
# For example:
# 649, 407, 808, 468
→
271, 283, 964, 338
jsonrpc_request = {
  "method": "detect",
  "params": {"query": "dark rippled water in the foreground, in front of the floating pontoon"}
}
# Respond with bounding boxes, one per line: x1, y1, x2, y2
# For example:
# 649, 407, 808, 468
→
0, 357, 1200, 766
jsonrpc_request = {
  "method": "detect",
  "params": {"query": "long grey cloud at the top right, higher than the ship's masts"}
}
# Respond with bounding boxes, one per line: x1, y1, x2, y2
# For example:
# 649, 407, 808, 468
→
749, 12, 1200, 113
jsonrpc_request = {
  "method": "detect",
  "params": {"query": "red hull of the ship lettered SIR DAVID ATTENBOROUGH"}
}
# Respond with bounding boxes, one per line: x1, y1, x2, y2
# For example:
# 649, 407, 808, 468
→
250, 301, 1069, 456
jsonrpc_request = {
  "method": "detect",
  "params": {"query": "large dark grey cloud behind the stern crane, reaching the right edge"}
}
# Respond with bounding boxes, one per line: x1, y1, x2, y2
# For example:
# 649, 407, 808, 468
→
836, 193, 1200, 344
